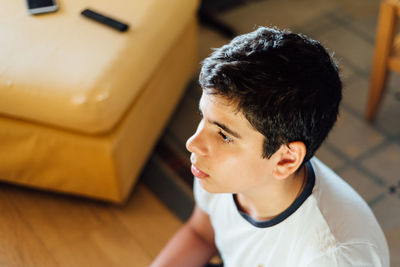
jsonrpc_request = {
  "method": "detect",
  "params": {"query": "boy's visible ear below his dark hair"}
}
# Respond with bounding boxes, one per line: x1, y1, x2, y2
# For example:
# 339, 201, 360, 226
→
273, 141, 306, 179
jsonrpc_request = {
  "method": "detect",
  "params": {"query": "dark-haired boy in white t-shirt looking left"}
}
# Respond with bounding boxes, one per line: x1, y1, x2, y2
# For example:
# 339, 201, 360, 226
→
152, 27, 389, 267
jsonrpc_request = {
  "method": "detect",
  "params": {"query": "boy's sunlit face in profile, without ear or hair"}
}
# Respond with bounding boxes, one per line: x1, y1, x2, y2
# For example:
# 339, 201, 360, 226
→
186, 93, 275, 193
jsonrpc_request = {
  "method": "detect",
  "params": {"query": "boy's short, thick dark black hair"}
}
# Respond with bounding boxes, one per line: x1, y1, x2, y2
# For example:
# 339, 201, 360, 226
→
199, 27, 342, 162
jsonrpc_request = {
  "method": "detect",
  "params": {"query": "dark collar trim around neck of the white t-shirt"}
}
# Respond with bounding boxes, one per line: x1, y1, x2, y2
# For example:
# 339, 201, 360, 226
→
233, 161, 315, 228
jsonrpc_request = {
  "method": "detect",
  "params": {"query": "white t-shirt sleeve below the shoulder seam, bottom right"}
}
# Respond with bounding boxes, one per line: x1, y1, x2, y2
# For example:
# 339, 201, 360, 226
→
307, 243, 389, 267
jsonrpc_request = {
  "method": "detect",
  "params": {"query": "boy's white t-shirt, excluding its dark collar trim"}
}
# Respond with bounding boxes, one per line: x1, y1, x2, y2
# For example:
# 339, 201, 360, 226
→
194, 158, 389, 267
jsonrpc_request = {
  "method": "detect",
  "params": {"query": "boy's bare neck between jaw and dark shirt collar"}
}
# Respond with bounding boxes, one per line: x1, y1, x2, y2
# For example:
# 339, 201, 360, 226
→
236, 165, 308, 221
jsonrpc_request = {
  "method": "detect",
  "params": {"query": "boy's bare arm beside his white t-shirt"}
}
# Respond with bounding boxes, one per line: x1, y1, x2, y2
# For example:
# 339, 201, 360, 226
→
151, 205, 217, 267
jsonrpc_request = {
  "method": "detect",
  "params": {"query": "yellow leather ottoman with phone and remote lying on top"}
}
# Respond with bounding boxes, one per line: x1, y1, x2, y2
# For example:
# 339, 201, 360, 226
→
0, 0, 198, 202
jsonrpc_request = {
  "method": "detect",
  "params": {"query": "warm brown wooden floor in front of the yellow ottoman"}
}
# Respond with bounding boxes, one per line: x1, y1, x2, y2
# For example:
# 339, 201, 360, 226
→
0, 183, 181, 267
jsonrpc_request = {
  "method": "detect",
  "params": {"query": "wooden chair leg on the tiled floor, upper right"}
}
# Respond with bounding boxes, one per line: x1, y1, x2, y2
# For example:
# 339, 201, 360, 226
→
365, 2, 398, 121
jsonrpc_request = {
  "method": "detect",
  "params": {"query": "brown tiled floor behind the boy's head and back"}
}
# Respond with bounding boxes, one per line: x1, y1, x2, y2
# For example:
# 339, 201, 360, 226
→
143, 0, 400, 267
